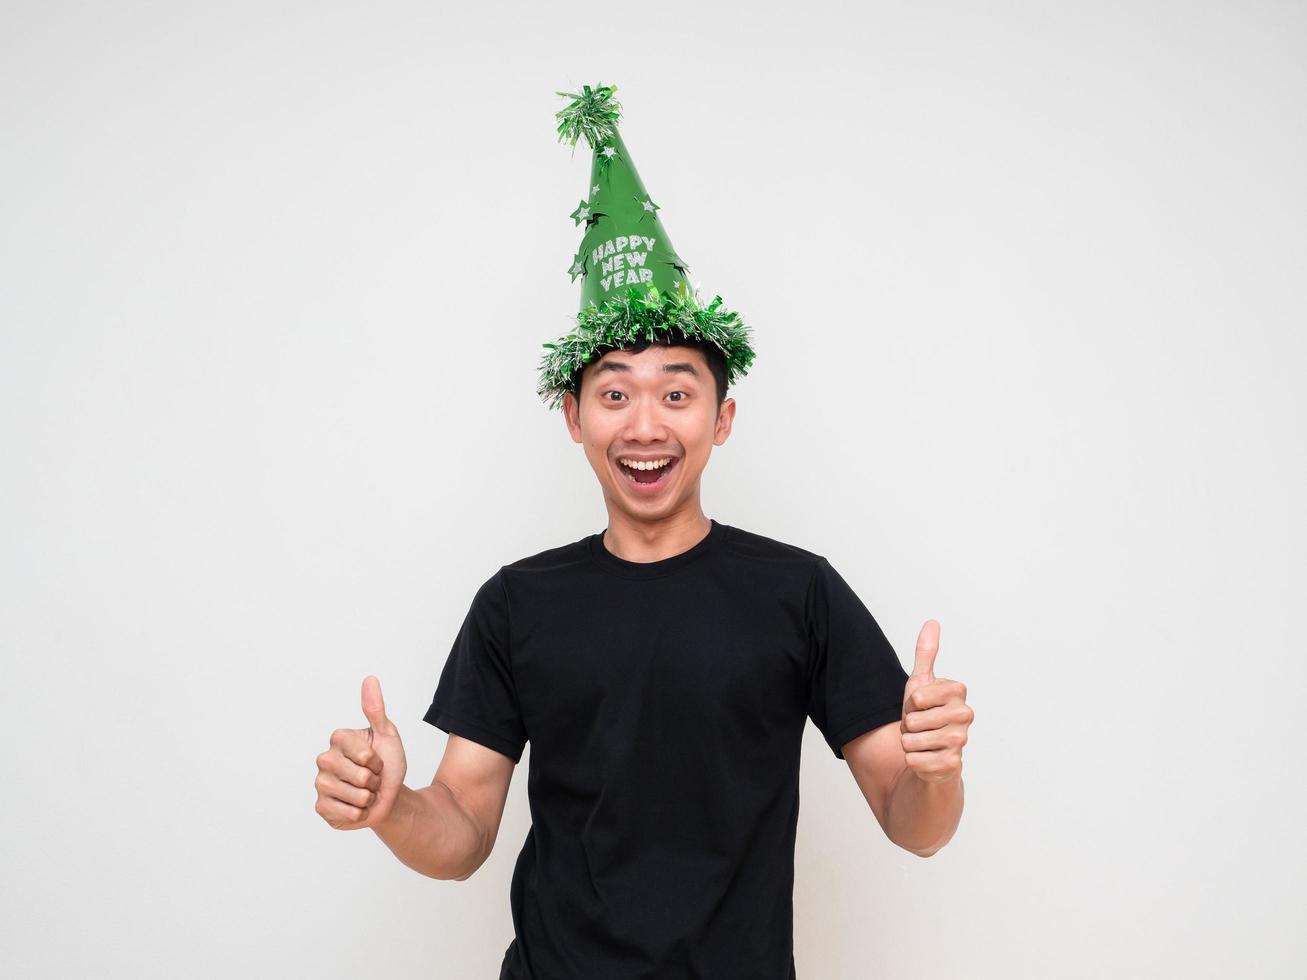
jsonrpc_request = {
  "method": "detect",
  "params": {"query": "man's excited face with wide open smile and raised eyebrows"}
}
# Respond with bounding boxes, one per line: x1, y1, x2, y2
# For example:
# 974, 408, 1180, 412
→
563, 344, 735, 520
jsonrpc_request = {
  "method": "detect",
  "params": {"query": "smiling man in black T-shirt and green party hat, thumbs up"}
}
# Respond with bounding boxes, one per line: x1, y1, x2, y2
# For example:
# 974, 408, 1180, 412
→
316, 86, 972, 980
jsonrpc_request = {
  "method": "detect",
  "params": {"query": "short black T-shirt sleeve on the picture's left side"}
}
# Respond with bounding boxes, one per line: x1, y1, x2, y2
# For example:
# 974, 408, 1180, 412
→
422, 568, 527, 762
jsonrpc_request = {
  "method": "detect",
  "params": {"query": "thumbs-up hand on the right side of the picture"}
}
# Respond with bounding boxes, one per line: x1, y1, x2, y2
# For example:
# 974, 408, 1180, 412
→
899, 619, 972, 783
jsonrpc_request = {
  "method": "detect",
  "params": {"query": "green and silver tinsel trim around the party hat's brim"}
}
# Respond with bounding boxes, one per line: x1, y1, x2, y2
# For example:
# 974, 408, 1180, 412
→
536, 286, 754, 409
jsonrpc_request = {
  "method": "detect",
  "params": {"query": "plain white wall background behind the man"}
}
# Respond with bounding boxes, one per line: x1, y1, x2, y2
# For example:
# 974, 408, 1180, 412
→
0, 3, 1307, 980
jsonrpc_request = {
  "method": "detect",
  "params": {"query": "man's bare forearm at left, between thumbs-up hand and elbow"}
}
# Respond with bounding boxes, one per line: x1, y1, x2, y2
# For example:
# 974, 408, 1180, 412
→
372, 781, 485, 881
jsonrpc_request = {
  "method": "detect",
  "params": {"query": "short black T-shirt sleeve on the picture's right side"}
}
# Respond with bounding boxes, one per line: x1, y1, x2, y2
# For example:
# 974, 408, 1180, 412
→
804, 558, 908, 759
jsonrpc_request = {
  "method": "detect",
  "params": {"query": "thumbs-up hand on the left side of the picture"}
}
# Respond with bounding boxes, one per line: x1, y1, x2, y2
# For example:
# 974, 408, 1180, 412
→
314, 674, 408, 830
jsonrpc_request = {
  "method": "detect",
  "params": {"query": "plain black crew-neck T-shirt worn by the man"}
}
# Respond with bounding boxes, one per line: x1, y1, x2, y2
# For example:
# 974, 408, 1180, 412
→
423, 520, 907, 980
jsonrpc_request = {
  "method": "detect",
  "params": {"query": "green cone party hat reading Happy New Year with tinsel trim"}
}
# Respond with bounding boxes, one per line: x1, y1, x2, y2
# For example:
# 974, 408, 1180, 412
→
537, 85, 754, 408
